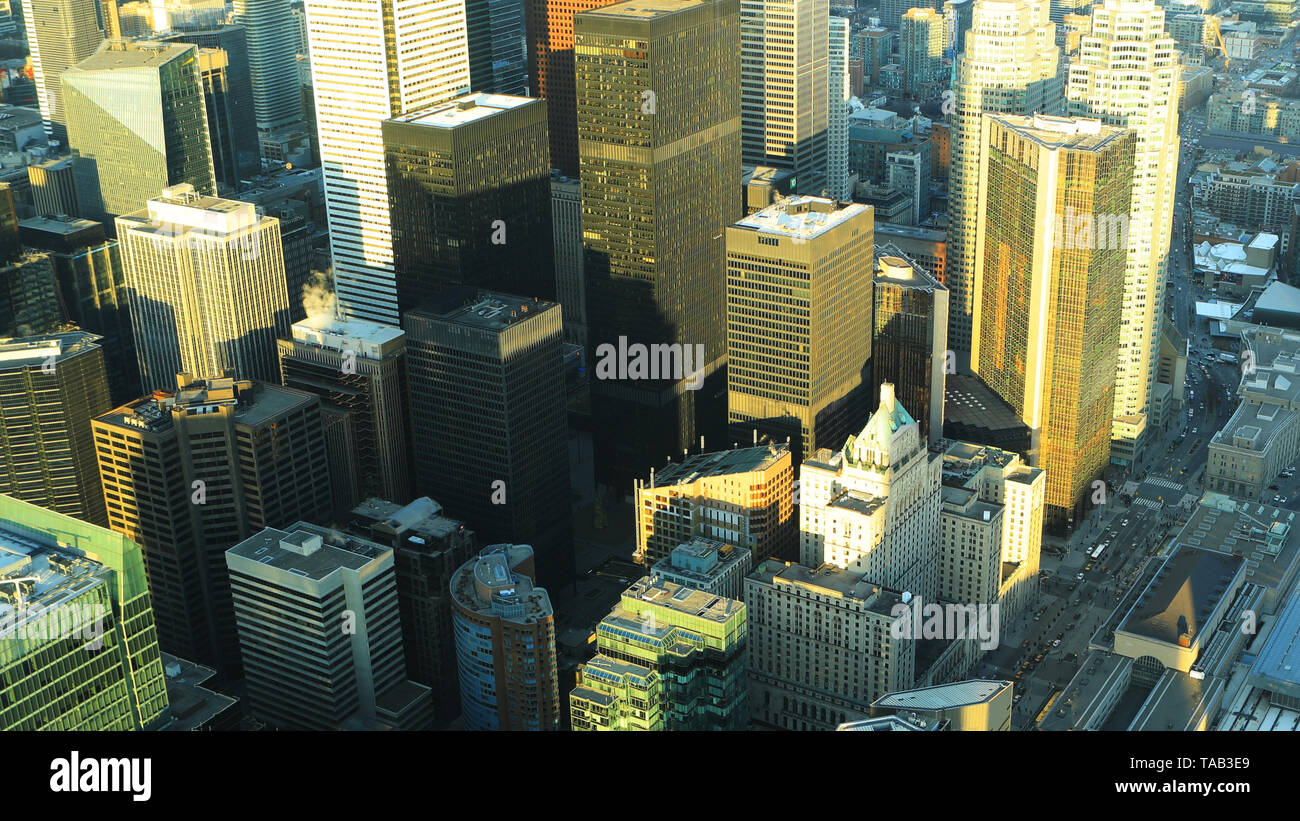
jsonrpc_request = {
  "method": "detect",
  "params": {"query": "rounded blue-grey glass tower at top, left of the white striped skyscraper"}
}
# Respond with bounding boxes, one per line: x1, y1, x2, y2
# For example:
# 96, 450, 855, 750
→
233, 0, 305, 133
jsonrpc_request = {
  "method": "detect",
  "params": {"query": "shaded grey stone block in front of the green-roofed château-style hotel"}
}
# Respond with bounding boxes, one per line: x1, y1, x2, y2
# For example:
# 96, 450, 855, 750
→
745, 559, 919, 730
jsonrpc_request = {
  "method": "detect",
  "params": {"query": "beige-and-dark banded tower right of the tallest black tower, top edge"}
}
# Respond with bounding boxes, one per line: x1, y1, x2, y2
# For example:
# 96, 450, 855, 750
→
740, 0, 826, 195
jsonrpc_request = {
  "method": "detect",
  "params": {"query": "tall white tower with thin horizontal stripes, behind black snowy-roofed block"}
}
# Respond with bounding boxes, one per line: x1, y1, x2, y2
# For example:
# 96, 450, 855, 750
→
304, 0, 469, 325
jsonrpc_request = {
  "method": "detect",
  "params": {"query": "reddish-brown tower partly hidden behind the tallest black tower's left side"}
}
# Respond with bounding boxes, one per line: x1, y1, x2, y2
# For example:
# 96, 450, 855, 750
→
524, 0, 608, 177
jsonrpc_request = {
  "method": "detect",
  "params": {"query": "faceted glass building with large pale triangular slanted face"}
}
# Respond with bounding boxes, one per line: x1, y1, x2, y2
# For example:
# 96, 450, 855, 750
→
62, 40, 217, 230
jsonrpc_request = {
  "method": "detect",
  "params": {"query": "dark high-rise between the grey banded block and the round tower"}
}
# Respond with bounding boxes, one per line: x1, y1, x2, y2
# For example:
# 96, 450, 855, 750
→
348, 496, 477, 725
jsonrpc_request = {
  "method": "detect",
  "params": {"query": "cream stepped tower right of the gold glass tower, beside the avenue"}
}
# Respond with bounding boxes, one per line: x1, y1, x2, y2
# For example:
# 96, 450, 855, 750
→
1066, 0, 1182, 464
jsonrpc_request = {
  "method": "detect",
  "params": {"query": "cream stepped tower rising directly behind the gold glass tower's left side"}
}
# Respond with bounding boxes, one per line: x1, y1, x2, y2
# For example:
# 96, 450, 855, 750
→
944, 0, 1063, 368
